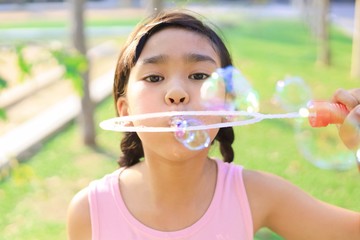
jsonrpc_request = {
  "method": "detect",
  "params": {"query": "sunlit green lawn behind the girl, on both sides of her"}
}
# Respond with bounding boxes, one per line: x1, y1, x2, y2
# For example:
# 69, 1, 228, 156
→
0, 17, 360, 240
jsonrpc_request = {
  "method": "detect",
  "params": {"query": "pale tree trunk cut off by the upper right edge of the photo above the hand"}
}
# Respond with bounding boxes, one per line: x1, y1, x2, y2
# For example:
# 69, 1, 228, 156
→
351, 0, 360, 78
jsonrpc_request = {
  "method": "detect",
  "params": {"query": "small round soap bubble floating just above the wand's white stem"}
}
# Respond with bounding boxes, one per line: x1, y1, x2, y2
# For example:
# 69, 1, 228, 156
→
275, 77, 312, 112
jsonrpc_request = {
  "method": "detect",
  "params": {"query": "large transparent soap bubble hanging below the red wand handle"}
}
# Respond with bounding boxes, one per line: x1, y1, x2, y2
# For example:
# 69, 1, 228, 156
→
295, 119, 356, 170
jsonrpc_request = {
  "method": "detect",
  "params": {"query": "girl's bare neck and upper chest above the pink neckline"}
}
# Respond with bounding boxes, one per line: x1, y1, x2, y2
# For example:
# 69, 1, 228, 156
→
119, 152, 217, 231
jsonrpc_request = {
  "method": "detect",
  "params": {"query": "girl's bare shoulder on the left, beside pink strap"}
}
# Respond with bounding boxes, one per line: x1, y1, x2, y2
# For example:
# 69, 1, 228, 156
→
67, 188, 91, 240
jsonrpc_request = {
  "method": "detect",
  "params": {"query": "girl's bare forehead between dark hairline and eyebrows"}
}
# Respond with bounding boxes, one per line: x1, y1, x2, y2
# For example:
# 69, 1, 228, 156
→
139, 27, 220, 65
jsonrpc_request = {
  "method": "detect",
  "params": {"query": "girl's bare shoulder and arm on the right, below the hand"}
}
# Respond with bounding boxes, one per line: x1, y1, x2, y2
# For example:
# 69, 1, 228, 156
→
243, 170, 360, 240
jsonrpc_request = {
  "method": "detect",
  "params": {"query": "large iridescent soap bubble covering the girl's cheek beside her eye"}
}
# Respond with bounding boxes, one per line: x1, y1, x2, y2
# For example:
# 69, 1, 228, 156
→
200, 66, 259, 112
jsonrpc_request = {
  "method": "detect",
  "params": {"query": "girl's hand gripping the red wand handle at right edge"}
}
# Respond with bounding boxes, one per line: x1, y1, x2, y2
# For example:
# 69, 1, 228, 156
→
332, 88, 360, 150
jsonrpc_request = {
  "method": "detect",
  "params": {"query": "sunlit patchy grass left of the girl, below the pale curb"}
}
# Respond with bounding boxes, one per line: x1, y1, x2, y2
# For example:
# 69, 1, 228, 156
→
0, 100, 120, 240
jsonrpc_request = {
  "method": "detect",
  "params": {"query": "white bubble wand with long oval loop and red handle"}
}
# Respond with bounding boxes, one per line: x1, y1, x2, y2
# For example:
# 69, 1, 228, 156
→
100, 101, 349, 132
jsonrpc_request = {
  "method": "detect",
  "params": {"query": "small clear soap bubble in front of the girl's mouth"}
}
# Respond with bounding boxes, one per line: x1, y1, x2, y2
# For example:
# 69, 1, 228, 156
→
171, 116, 211, 150
